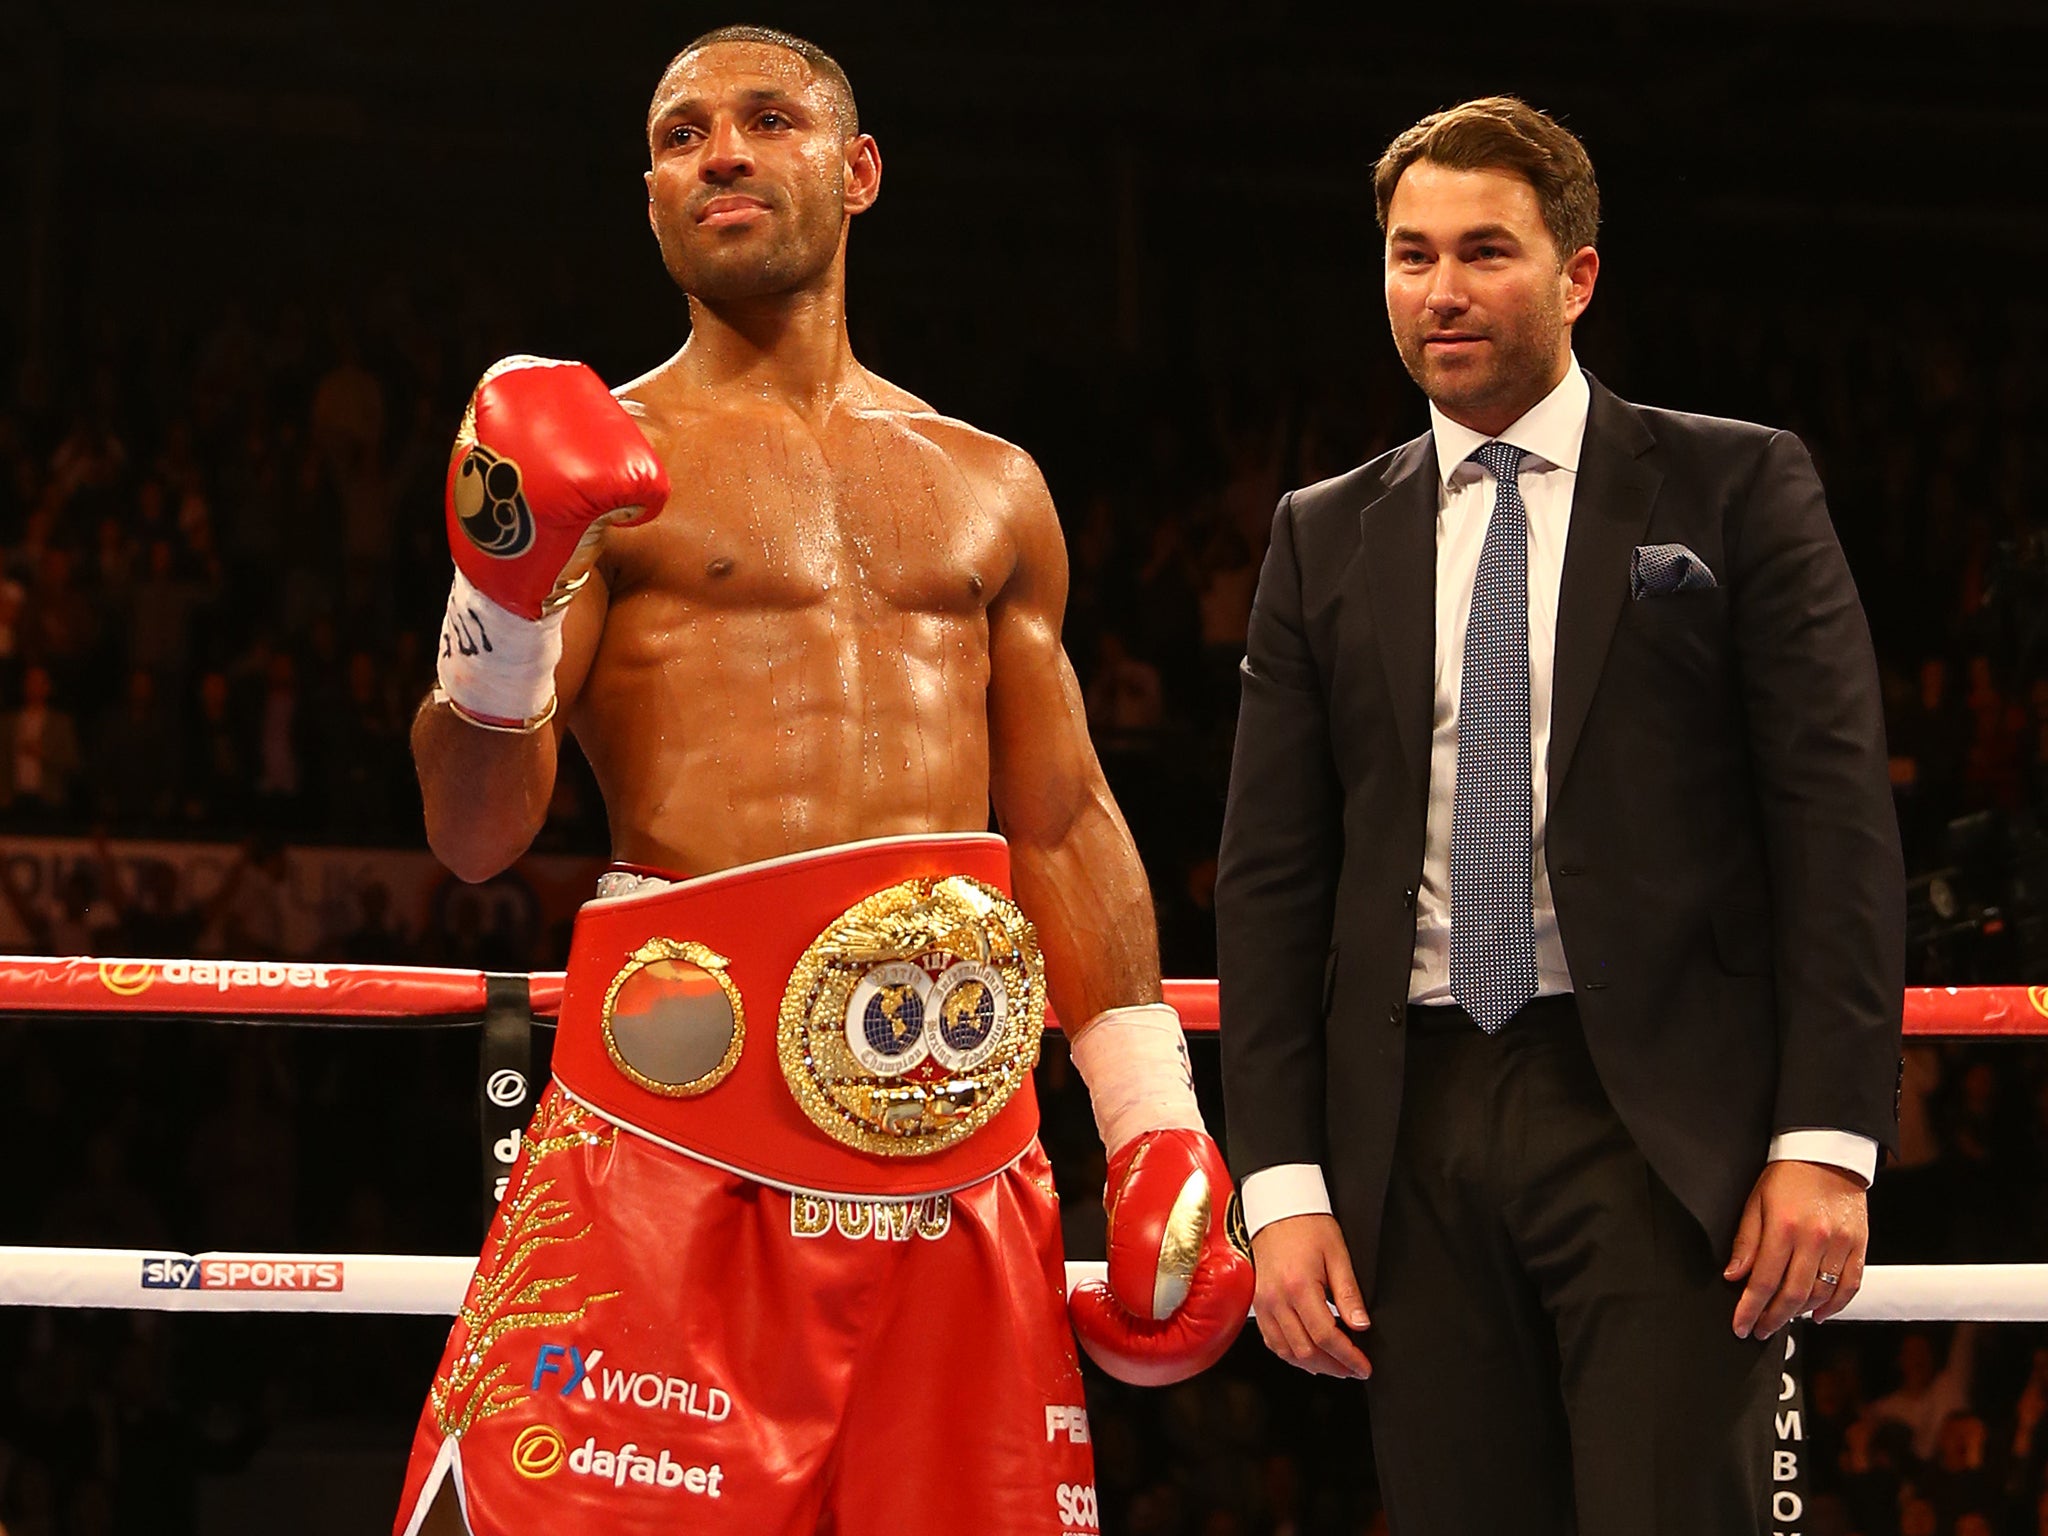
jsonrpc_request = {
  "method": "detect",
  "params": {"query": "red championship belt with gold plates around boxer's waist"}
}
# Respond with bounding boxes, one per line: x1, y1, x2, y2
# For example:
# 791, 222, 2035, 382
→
555, 834, 1047, 1198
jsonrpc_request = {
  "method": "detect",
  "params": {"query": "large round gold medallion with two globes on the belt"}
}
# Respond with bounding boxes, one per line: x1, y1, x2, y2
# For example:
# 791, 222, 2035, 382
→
776, 874, 1044, 1157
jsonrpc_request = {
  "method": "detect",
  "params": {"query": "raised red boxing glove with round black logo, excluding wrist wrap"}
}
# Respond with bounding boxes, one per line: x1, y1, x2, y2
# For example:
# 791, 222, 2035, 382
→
446, 356, 668, 618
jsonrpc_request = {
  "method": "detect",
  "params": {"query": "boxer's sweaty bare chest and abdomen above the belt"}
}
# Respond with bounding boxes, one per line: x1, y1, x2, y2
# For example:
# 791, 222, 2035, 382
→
573, 397, 1018, 870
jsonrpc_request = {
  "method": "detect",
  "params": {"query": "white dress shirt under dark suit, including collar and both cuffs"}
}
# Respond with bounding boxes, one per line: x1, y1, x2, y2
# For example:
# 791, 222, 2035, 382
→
1243, 366, 1878, 1235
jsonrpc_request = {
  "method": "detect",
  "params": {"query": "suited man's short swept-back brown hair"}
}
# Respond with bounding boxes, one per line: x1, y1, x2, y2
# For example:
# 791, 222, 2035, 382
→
1372, 96, 1599, 260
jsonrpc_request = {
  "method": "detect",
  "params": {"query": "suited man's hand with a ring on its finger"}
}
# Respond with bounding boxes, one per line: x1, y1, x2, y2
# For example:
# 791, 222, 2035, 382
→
1722, 1159, 1870, 1339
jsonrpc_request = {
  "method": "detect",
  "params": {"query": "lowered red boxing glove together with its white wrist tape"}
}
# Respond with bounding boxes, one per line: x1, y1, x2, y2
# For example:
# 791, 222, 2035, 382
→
1067, 1004, 1251, 1386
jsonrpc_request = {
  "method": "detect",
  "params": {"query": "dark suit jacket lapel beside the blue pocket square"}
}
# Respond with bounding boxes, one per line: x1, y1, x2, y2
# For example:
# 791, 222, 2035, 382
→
1550, 379, 1663, 805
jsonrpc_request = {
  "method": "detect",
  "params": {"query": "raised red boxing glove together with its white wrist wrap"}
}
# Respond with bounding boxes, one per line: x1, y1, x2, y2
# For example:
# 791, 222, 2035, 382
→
438, 356, 668, 731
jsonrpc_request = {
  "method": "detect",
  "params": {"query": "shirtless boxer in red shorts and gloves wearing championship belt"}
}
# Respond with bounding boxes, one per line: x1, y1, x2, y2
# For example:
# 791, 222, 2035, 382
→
385, 29, 1251, 1536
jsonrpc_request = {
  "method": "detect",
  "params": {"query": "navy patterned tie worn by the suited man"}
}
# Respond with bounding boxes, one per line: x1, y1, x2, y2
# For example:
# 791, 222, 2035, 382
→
1450, 442, 1536, 1034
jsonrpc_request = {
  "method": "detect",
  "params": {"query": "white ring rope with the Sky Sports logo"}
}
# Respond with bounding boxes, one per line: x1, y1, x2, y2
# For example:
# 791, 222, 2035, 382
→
0, 1247, 2048, 1323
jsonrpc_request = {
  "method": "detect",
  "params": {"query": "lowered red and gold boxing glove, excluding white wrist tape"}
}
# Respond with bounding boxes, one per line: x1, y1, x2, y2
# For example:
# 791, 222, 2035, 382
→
1067, 1128, 1251, 1386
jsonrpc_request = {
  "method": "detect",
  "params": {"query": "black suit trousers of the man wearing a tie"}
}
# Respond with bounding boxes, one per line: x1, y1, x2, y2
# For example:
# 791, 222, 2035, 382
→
1364, 997, 1784, 1536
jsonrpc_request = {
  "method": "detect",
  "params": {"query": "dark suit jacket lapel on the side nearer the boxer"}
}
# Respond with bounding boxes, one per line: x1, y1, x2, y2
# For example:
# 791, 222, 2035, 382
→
1358, 434, 1438, 784
